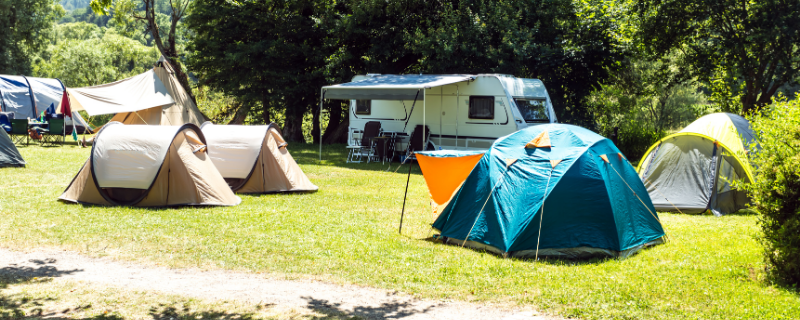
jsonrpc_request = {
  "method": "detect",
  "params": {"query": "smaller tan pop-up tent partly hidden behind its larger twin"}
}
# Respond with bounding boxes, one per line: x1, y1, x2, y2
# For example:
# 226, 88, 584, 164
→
200, 122, 319, 193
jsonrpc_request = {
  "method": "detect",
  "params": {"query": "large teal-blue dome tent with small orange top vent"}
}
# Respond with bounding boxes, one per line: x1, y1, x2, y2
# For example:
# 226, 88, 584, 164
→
428, 124, 664, 258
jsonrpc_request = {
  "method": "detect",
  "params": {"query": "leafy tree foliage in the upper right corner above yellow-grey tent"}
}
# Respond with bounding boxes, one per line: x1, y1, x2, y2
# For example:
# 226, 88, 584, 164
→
635, 0, 800, 113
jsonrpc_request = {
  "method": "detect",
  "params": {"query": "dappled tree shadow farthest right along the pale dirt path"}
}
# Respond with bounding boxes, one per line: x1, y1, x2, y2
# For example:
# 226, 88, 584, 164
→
303, 297, 435, 319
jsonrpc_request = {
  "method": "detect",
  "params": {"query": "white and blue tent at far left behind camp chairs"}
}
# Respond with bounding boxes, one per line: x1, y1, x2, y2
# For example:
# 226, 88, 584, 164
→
0, 75, 92, 134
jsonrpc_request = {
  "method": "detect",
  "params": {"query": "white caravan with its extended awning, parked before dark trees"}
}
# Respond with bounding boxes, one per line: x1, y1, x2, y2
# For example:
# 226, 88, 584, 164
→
321, 74, 556, 156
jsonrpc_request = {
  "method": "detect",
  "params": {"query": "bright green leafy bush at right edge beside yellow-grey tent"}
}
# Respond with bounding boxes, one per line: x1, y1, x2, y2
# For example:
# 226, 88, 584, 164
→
745, 98, 800, 289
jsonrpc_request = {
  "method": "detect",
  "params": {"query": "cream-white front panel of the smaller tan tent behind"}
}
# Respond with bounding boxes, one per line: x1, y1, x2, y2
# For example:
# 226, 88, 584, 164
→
200, 122, 269, 179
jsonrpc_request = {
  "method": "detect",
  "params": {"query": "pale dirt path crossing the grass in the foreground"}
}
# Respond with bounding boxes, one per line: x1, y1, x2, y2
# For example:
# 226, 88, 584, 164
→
0, 249, 554, 320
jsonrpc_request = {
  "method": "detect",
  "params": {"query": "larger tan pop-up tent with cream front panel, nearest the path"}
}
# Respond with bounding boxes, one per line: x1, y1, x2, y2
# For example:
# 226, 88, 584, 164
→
59, 122, 241, 207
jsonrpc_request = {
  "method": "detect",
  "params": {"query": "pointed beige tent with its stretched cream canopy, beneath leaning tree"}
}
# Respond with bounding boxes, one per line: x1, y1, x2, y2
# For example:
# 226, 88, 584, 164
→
67, 58, 205, 126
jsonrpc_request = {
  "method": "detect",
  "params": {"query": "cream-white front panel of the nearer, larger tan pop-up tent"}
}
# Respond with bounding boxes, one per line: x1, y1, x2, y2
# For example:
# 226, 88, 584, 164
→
92, 122, 181, 189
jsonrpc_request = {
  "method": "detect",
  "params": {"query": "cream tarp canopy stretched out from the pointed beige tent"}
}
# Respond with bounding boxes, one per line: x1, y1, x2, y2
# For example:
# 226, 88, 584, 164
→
67, 69, 175, 116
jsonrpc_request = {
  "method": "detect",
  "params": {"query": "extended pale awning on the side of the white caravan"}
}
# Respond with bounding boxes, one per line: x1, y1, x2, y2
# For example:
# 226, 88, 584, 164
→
322, 75, 475, 100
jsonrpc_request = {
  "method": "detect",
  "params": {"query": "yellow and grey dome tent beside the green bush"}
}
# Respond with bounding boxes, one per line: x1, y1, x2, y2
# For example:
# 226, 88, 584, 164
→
637, 113, 755, 216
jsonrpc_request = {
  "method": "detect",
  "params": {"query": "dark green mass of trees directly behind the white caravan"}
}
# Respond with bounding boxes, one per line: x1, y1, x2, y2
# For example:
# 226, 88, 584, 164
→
187, 0, 622, 139
